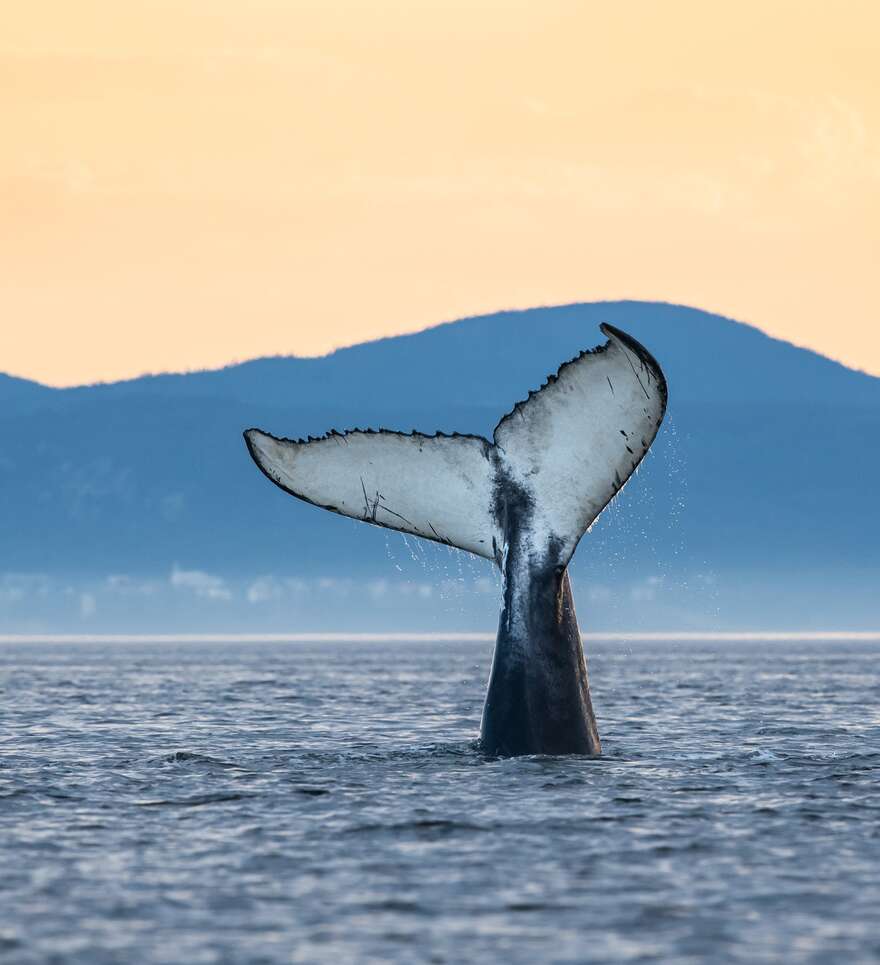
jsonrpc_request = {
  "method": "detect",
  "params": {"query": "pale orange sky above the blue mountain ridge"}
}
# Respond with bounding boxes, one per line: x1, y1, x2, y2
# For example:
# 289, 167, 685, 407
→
0, 0, 880, 385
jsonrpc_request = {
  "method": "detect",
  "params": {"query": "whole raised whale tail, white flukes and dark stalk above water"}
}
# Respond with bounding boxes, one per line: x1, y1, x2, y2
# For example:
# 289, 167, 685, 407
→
245, 325, 667, 754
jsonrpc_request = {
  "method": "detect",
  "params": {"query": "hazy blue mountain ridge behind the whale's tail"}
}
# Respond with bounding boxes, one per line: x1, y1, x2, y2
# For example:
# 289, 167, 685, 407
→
0, 302, 880, 631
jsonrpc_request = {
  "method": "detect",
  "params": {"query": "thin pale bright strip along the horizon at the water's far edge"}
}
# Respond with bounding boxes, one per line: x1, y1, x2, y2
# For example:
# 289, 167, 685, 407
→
0, 630, 880, 645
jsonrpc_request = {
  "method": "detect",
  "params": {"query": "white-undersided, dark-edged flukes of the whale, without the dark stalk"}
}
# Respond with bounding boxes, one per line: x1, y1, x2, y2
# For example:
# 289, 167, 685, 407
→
244, 325, 667, 566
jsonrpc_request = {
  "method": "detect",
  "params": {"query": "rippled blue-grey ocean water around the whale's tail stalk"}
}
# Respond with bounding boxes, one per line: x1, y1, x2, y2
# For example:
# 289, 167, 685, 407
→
0, 642, 880, 965
